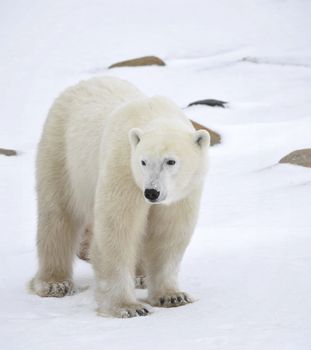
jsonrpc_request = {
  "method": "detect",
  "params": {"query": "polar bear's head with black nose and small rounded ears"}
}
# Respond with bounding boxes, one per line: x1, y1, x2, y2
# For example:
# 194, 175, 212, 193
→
129, 128, 210, 204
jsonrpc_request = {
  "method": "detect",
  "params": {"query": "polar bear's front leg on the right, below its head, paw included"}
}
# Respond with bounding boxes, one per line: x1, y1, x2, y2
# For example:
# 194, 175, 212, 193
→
144, 197, 198, 307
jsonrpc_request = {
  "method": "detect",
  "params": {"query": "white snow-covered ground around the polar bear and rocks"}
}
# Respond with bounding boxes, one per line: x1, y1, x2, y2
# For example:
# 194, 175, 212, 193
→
0, 0, 311, 350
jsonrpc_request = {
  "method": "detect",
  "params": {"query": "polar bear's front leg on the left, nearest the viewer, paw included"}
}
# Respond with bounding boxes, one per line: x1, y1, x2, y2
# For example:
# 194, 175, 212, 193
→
91, 179, 151, 318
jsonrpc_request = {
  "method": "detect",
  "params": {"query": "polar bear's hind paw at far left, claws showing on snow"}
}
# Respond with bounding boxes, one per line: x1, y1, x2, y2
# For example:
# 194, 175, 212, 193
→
29, 278, 74, 298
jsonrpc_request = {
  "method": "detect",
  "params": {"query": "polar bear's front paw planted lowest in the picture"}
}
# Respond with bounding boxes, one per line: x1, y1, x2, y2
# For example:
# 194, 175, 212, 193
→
97, 304, 152, 318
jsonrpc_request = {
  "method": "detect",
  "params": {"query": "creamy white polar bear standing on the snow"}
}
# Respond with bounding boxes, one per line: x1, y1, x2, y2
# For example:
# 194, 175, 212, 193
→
29, 77, 210, 317
